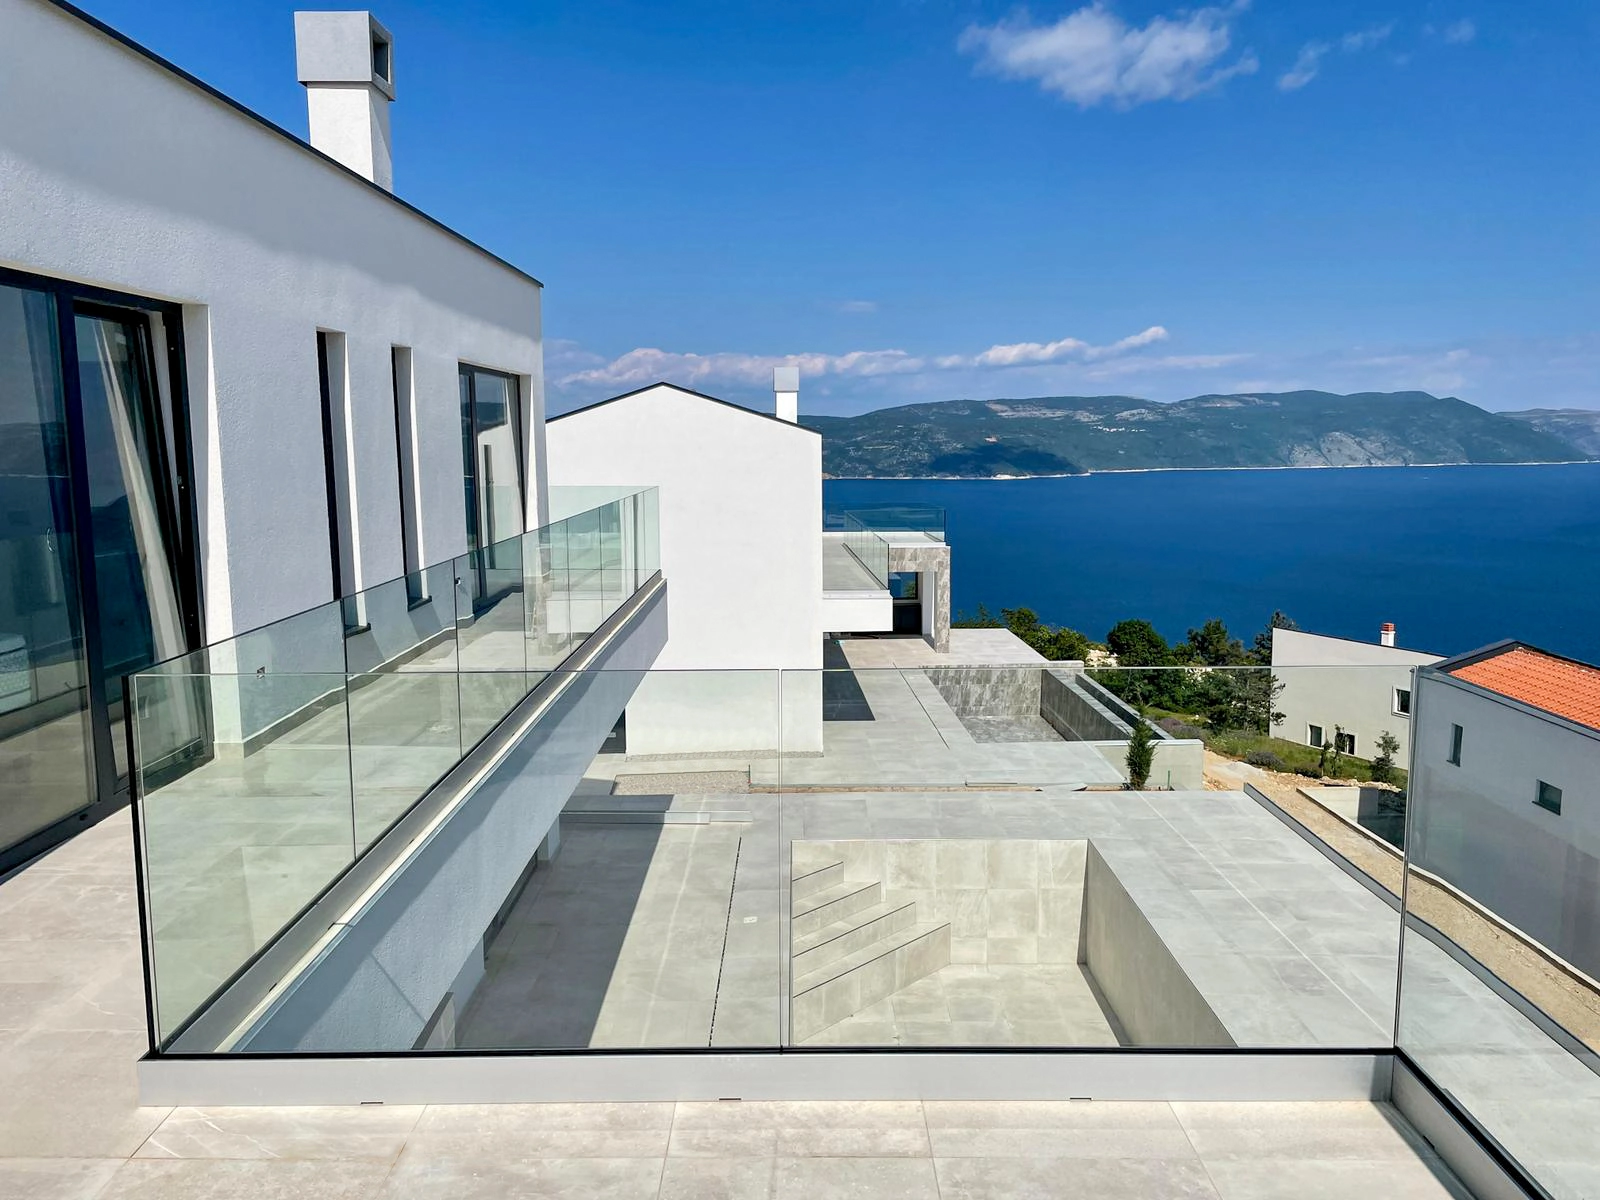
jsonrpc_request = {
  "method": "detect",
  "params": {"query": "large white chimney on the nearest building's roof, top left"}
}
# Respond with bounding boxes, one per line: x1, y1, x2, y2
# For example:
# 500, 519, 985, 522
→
294, 13, 395, 192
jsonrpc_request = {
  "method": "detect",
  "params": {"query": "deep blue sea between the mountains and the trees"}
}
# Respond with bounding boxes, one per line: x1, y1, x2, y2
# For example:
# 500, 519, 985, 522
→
822, 464, 1600, 662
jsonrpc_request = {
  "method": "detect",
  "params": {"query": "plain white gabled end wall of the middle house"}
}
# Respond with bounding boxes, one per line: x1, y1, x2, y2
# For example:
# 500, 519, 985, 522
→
546, 386, 822, 754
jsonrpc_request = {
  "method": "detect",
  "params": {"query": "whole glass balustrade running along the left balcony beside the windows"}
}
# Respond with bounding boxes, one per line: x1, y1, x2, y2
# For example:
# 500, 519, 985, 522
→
128, 490, 659, 1042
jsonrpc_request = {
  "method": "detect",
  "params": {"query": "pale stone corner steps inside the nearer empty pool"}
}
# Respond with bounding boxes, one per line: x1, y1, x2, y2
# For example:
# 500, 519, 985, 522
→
789, 862, 950, 1042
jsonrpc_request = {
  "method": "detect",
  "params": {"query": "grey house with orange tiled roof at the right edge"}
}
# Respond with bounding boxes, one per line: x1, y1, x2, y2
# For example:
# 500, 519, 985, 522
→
1408, 642, 1600, 976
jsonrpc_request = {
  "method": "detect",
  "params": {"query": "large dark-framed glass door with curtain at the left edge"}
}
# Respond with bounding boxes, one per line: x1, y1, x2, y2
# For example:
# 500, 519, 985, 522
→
0, 272, 203, 867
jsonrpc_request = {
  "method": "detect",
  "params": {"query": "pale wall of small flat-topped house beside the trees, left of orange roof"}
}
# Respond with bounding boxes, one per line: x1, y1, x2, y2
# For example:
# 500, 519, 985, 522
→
1272, 629, 1438, 766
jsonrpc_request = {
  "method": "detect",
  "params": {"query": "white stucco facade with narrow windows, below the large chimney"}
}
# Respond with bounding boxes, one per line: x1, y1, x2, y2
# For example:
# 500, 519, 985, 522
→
0, 0, 544, 642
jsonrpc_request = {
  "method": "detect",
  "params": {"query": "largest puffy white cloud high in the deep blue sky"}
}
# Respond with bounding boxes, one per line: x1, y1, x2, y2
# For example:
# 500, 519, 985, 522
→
957, 0, 1259, 109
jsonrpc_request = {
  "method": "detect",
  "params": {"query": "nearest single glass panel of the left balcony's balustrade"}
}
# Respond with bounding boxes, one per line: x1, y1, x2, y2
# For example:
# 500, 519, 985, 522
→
130, 662, 355, 1042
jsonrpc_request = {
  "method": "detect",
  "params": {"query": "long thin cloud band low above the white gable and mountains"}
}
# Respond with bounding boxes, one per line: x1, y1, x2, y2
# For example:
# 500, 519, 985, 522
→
558, 325, 1168, 387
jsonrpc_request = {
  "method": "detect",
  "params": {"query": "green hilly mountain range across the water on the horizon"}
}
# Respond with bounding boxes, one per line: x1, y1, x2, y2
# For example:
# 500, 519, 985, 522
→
802, 392, 1600, 478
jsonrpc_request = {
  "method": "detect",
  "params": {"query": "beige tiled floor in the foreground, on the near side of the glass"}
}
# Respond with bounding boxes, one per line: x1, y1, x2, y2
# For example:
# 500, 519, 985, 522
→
0, 793, 1466, 1200
